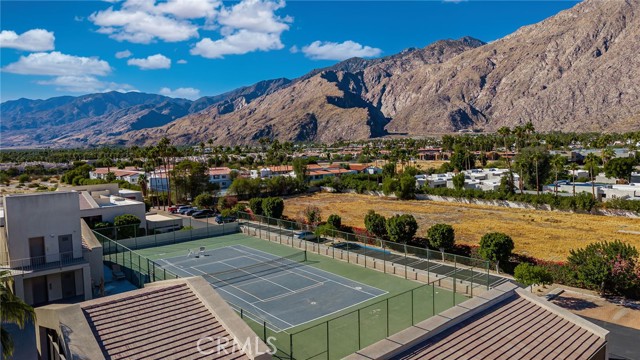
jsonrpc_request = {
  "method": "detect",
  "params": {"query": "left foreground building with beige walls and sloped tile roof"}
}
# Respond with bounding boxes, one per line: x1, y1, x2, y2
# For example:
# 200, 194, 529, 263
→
35, 277, 272, 360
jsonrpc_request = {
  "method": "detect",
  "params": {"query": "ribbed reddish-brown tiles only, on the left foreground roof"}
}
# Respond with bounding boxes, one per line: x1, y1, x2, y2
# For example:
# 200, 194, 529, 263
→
82, 284, 249, 359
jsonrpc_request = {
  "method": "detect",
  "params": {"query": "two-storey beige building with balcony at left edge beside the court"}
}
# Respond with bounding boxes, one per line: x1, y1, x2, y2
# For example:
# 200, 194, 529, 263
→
0, 191, 103, 305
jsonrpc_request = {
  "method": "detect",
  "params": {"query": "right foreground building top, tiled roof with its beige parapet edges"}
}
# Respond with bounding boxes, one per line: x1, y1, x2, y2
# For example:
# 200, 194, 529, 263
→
345, 283, 609, 360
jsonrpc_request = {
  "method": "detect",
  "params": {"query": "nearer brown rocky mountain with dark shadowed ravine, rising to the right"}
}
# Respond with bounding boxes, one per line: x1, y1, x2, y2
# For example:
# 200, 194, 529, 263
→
123, 0, 640, 144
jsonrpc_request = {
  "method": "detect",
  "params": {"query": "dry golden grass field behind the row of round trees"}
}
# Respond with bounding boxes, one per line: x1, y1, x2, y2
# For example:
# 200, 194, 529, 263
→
285, 193, 640, 261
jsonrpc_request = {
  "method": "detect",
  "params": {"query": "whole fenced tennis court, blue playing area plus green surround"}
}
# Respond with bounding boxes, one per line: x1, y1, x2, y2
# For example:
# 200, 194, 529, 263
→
136, 233, 468, 359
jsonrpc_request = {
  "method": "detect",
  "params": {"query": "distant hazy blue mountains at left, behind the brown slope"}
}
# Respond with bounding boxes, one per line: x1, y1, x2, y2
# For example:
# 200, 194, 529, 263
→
0, 79, 290, 147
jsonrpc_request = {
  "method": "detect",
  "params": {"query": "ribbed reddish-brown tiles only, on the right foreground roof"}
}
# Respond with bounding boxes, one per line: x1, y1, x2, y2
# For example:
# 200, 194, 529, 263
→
395, 296, 605, 360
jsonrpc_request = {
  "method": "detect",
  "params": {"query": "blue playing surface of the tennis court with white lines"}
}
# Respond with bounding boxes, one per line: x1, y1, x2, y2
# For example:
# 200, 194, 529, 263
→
159, 245, 386, 330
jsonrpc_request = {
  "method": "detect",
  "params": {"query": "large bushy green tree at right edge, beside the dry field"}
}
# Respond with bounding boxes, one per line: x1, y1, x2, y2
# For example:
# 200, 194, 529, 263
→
567, 240, 640, 297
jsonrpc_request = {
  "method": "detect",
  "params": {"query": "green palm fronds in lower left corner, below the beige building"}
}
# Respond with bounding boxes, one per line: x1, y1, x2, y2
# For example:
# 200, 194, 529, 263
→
0, 270, 36, 358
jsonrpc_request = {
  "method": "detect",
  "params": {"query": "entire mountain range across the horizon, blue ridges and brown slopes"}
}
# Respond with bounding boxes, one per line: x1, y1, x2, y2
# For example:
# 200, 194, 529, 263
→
0, 0, 640, 147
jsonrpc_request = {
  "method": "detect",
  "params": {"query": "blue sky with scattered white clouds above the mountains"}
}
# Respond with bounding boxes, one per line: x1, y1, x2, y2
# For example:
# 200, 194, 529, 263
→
0, 0, 576, 101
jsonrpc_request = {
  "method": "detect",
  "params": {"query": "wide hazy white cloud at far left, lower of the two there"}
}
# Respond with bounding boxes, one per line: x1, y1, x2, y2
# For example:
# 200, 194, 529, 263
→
2, 51, 111, 76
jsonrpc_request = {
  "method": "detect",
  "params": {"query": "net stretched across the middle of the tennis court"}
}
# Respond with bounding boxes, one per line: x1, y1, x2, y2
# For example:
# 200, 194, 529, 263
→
203, 251, 307, 287
